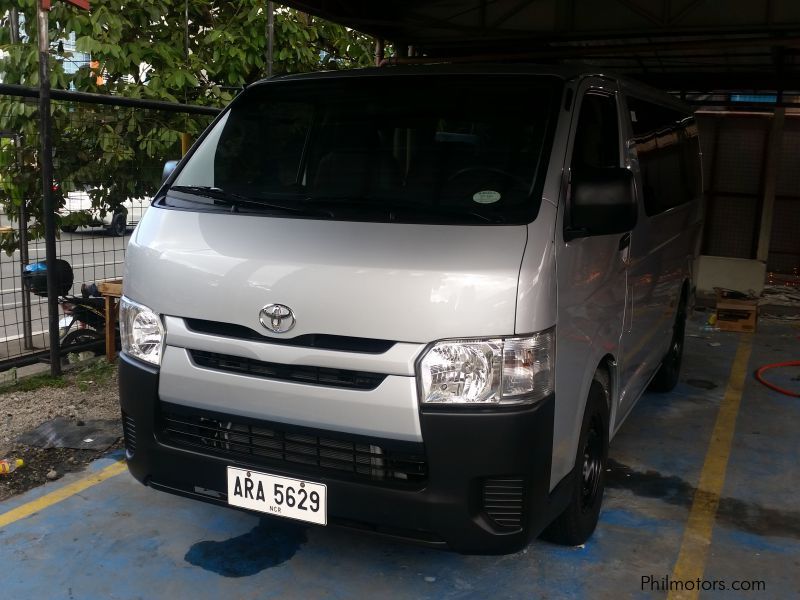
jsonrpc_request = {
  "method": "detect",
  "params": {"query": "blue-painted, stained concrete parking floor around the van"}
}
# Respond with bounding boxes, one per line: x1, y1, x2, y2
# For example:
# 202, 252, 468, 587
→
0, 319, 800, 600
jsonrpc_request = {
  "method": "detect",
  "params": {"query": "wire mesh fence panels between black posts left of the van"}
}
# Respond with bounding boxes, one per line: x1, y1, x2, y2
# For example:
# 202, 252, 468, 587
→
0, 84, 218, 371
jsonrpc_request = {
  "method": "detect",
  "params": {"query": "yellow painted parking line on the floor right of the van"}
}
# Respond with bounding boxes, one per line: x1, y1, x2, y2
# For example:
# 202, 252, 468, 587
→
667, 334, 752, 600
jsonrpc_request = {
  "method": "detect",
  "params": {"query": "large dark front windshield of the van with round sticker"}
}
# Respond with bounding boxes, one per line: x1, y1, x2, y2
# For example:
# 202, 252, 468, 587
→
164, 74, 561, 224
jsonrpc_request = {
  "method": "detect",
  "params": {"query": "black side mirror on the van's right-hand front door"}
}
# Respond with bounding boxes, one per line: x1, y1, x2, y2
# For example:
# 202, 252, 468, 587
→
564, 168, 637, 241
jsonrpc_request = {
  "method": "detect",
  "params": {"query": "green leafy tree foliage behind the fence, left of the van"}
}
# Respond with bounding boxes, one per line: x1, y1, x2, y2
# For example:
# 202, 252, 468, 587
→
0, 0, 374, 252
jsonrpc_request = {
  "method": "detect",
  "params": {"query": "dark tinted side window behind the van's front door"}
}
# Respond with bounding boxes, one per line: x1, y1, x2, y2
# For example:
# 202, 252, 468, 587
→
628, 97, 701, 216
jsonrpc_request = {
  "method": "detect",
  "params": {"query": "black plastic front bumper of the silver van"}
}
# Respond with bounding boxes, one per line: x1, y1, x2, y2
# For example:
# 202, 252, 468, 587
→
119, 355, 560, 553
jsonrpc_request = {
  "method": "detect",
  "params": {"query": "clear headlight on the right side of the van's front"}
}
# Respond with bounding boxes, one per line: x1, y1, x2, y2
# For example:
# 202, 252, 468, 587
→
418, 329, 555, 405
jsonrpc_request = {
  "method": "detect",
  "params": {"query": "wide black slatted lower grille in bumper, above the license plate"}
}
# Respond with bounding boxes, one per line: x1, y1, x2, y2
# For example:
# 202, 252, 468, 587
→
160, 404, 427, 487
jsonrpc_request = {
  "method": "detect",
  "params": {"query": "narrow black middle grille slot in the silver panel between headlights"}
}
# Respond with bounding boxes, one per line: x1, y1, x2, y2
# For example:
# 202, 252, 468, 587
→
189, 350, 386, 390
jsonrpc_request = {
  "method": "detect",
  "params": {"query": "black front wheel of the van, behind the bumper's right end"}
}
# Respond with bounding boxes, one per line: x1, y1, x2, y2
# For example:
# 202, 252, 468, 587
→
542, 381, 608, 546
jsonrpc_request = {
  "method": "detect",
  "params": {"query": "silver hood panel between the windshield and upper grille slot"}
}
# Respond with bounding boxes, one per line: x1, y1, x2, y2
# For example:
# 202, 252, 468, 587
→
124, 206, 527, 343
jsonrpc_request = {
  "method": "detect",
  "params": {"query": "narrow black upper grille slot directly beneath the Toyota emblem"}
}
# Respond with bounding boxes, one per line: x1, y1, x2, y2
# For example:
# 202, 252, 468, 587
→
184, 319, 395, 354
